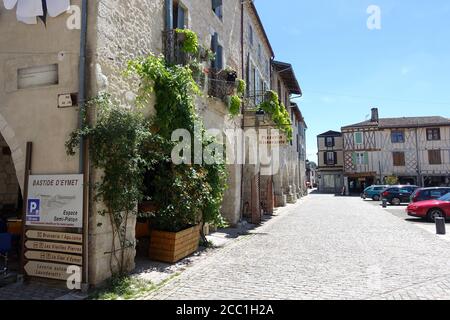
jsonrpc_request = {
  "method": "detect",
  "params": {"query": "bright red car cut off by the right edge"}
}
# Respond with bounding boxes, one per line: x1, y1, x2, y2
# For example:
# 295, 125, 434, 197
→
406, 193, 450, 222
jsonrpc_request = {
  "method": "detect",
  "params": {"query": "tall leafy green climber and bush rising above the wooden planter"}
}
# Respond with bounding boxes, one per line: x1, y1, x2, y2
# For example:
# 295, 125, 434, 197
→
128, 55, 227, 231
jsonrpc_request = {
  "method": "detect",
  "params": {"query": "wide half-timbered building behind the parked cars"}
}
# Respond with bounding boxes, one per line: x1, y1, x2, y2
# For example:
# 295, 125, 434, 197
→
342, 108, 450, 192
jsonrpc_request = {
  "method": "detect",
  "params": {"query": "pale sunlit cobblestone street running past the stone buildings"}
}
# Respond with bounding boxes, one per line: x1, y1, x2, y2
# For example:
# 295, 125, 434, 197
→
146, 194, 450, 300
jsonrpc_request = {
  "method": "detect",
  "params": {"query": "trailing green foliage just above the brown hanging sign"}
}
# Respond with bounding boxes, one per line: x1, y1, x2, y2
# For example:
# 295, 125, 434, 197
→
258, 91, 293, 140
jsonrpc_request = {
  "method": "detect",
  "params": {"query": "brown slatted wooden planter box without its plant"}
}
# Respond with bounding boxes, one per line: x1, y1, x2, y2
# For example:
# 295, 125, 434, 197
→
149, 226, 200, 263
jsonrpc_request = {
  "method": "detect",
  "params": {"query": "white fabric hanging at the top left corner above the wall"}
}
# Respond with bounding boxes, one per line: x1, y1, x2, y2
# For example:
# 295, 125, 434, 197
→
3, 0, 70, 24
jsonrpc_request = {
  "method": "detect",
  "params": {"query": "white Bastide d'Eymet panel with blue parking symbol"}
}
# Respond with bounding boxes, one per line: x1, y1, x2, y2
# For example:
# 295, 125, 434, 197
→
26, 174, 83, 228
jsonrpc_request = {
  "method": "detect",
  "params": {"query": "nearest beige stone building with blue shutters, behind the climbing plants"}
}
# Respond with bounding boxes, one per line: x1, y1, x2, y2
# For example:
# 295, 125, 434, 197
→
0, 0, 308, 285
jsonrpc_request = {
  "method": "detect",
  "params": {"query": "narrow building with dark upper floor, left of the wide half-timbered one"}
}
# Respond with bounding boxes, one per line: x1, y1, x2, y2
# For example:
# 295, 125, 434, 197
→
317, 131, 344, 194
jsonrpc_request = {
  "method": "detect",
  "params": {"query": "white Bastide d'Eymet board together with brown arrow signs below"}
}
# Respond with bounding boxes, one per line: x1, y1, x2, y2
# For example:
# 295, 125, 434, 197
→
24, 174, 84, 280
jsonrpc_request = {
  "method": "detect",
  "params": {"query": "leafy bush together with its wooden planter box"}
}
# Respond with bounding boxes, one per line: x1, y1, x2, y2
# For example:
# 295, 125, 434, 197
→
149, 164, 204, 263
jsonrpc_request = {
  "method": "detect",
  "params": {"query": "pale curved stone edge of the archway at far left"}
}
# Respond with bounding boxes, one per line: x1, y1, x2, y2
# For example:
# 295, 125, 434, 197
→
0, 113, 25, 196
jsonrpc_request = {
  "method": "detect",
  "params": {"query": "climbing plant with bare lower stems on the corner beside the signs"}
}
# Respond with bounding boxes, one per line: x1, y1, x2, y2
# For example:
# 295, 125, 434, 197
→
66, 94, 162, 274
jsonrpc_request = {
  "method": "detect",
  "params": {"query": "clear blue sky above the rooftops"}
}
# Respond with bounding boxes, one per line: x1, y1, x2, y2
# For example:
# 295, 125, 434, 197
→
255, 0, 450, 161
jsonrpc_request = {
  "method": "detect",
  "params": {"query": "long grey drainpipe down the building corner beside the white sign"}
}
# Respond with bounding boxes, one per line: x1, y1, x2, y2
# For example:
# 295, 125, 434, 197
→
78, 0, 89, 290
